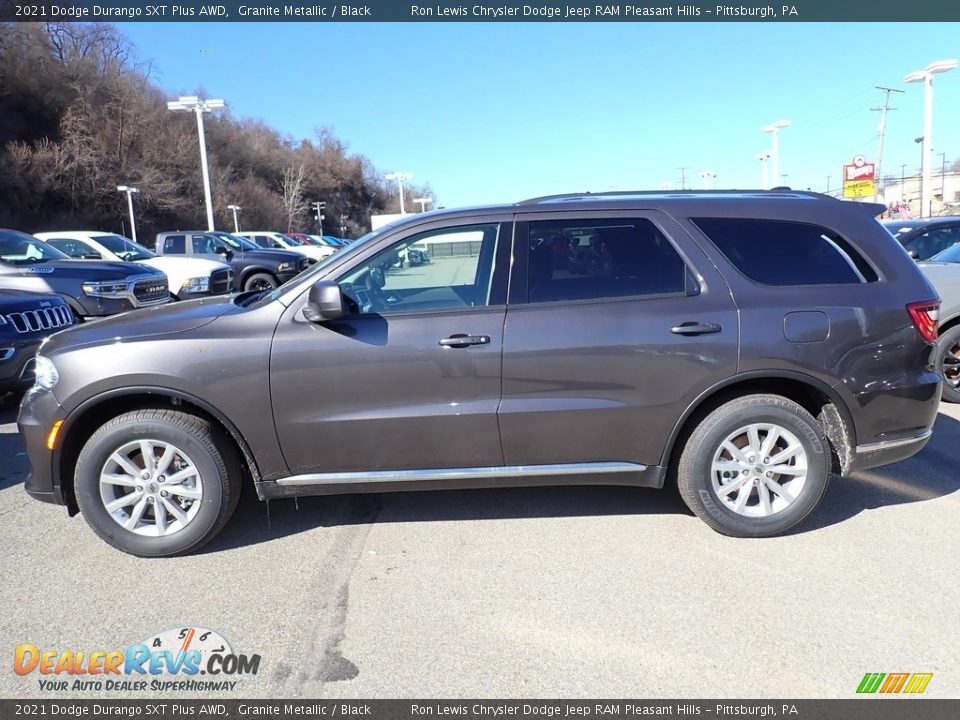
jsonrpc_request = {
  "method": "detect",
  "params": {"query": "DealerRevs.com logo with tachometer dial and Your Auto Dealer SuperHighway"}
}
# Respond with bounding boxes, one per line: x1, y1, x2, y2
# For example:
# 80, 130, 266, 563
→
13, 627, 260, 692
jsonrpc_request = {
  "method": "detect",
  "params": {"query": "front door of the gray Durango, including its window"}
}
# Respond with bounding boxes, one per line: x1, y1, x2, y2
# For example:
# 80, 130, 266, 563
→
270, 216, 512, 482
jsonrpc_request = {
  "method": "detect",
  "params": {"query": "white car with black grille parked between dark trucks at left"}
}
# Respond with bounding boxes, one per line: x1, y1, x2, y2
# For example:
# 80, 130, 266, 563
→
34, 230, 233, 300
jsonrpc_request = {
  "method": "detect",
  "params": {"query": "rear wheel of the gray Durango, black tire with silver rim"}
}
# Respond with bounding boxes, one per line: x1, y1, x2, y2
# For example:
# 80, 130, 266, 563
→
677, 395, 831, 537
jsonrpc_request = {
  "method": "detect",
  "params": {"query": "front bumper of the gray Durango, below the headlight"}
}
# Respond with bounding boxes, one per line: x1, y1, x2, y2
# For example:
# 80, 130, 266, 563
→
17, 389, 68, 505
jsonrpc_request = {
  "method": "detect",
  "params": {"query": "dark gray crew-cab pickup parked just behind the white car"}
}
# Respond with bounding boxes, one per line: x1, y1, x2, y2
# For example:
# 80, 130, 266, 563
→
156, 230, 311, 291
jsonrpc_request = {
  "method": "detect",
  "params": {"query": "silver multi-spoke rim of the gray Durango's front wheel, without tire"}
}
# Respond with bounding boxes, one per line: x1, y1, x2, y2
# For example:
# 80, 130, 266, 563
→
100, 440, 203, 537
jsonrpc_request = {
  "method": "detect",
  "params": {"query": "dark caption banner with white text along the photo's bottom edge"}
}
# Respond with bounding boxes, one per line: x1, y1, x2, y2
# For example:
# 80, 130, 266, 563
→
0, 697, 960, 720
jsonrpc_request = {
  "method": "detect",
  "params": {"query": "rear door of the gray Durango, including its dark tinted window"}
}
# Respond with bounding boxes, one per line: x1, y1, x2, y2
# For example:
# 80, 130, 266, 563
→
499, 211, 738, 470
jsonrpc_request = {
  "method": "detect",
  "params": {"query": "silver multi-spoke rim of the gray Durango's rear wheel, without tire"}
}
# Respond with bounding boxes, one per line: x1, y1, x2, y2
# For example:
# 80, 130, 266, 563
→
710, 423, 807, 517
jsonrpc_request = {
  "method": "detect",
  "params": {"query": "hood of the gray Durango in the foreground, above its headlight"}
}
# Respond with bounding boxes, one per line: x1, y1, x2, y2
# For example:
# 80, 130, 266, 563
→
43, 295, 238, 355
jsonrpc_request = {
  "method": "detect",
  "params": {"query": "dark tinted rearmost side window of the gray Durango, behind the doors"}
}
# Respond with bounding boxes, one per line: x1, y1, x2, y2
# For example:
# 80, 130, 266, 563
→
691, 218, 877, 285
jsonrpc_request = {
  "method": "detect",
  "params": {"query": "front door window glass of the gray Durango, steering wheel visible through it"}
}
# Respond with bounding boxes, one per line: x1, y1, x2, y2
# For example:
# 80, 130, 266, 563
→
338, 223, 501, 314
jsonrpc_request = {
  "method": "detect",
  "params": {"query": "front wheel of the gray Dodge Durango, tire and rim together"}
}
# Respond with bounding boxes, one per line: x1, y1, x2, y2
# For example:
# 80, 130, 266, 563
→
75, 409, 240, 557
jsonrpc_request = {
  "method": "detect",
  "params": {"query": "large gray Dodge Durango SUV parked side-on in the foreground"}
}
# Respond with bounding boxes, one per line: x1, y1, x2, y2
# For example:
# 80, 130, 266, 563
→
19, 190, 940, 556
